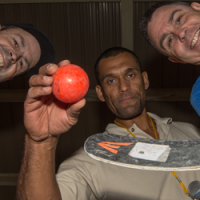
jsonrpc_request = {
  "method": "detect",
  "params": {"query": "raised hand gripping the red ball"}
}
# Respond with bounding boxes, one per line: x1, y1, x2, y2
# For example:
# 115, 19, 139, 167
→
24, 60, 86, 141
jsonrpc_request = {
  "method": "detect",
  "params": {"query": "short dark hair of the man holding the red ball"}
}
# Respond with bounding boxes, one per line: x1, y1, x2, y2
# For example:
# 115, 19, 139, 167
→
94, 47, 142, 85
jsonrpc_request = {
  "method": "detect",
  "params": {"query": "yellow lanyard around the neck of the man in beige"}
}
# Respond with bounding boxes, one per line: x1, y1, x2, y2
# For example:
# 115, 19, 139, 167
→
114, 114, 190, 196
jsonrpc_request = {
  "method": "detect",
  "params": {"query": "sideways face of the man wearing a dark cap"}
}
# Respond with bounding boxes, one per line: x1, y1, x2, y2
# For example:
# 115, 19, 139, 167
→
0, 28, 41, 82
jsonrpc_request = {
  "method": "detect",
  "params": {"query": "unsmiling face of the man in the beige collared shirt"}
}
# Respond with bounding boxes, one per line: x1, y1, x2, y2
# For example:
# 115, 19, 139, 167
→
96, 52, 149, 119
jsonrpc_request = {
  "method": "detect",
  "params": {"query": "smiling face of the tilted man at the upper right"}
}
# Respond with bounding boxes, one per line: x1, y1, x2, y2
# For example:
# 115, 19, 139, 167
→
148, 3, 200, 65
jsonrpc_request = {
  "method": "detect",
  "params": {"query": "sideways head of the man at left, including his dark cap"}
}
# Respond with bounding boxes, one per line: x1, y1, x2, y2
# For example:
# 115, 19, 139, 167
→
0, 24, 55, 82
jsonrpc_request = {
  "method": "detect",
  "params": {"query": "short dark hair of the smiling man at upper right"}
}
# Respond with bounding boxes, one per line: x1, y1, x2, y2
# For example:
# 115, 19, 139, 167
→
140, 1, 190, 47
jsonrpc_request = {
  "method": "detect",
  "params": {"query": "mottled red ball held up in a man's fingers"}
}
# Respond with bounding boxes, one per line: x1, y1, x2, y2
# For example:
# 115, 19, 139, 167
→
52, 64, 89, 103
